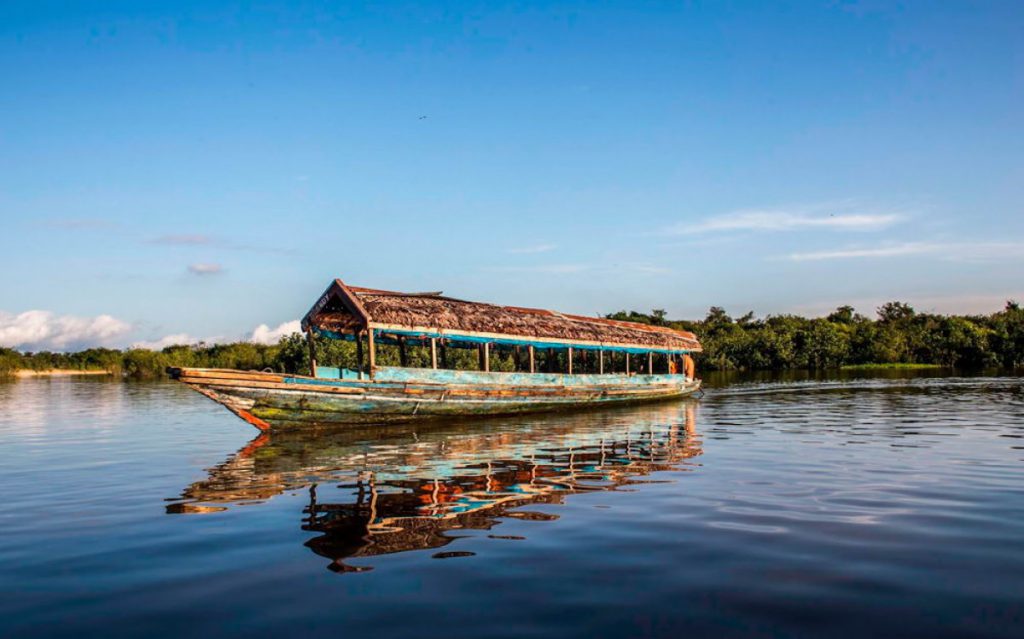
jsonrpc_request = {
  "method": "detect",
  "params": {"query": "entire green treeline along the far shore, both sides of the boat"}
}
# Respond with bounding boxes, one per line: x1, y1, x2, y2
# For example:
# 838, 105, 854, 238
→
0, 302, 1024, 379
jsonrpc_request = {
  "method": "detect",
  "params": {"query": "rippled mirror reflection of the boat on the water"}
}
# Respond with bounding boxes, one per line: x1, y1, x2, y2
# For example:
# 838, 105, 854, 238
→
167, 400, 701, 571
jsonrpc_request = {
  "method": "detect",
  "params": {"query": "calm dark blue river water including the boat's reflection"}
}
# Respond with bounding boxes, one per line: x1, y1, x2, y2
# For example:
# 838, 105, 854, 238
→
0, 377, 1024, 638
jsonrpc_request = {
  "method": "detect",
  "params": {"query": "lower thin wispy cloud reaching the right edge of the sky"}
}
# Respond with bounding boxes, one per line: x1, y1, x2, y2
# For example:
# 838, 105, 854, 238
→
784, 242, 1024, 262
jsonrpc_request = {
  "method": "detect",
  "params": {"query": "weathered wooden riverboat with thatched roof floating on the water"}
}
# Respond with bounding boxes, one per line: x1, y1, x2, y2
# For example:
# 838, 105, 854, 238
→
169, 280, 700, 430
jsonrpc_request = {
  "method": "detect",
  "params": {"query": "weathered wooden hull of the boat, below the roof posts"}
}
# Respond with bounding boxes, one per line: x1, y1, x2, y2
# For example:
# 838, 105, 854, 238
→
169, 368, 700, 430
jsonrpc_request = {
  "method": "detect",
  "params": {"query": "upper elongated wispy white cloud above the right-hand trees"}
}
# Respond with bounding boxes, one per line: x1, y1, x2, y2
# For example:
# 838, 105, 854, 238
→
665, 203, 906, 236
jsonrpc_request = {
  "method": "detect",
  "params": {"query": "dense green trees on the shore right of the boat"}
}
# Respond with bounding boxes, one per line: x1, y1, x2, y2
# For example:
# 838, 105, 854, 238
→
608, 301, 1024, 371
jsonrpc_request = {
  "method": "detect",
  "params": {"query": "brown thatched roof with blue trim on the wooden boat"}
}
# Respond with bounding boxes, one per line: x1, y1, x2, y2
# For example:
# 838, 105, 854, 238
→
302, 280, 700, 352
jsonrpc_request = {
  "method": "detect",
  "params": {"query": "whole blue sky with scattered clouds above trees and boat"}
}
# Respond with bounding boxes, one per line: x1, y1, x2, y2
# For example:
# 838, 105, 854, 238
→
0, 0, 1024, 348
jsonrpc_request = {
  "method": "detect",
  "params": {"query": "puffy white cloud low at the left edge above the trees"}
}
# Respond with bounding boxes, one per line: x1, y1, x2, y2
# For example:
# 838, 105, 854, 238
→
0, 310, 132, 350
